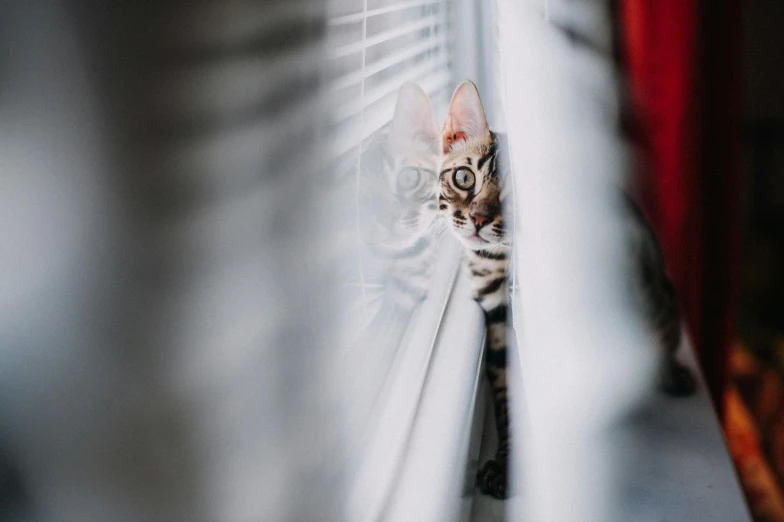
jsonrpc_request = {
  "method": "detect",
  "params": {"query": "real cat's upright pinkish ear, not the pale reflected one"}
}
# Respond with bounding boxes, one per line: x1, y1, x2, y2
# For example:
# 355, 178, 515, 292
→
441, 80, 490, 153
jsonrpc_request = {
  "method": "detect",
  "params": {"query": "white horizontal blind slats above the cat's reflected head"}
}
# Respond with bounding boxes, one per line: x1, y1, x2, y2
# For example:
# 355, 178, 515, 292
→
328, 0, 453, 159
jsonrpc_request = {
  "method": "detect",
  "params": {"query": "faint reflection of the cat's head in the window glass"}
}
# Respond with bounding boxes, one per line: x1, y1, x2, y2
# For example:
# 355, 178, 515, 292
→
361, 83, 441, 247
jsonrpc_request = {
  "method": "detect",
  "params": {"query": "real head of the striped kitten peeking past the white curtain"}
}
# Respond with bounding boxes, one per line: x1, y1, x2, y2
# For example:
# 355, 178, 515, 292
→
438, 81, 506, 250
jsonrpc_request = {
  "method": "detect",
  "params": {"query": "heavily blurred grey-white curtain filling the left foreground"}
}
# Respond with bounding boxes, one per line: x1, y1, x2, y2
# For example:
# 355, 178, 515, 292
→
0, 0, 342, 522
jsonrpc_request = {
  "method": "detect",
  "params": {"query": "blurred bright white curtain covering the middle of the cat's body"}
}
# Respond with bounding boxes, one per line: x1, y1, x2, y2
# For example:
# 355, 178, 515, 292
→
498, 0, 656, 522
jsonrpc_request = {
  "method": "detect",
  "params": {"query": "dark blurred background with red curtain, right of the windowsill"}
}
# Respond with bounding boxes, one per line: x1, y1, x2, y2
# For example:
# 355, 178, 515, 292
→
619, 1, 784, 520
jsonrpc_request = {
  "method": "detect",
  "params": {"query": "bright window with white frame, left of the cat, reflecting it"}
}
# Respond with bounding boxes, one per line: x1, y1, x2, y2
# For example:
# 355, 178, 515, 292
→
327, 0, 483, 520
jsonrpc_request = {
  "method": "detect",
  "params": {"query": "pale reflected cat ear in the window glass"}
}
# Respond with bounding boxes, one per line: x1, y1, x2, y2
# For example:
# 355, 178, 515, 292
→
390, 82, 441, 154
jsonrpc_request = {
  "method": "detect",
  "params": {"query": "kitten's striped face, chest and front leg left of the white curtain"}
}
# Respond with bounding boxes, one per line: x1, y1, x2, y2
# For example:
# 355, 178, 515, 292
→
438, 82, 510, 498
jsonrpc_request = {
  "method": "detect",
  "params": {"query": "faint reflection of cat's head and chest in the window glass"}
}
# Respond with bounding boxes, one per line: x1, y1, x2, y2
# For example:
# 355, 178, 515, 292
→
359, 83, 440, 313
